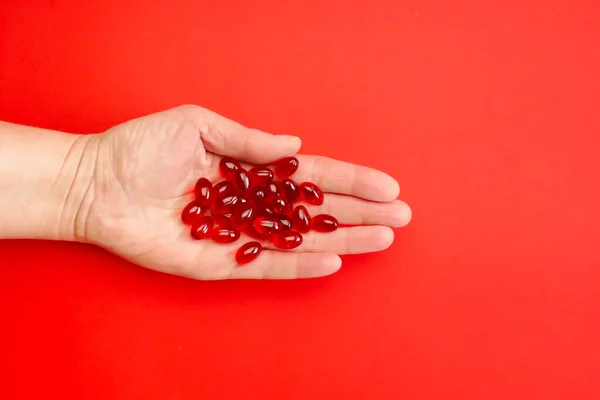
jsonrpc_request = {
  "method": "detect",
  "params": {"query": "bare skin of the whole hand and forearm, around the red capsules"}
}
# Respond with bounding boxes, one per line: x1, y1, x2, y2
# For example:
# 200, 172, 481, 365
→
0, 106, 411, 279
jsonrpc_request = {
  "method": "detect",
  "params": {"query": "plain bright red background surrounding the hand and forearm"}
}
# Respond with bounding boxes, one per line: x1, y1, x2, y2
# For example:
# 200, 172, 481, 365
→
0, 0, 600, 399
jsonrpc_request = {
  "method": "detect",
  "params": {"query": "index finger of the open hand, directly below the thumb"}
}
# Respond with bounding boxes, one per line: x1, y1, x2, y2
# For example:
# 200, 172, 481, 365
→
292, 155, 400, 202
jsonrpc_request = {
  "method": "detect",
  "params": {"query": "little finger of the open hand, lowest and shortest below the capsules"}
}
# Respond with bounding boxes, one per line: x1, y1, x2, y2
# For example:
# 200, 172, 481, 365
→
229, 250, 342, 279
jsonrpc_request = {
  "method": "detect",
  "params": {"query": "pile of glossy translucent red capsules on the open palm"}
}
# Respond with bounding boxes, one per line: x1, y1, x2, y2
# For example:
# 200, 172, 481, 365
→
181, 157, 338, 265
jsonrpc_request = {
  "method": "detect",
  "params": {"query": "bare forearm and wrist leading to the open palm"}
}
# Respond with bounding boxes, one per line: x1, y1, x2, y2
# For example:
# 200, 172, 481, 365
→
0, 122, 93, 240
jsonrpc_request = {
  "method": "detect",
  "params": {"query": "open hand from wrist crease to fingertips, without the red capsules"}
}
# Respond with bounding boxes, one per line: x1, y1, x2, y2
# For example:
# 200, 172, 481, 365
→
76, 106, 411, 279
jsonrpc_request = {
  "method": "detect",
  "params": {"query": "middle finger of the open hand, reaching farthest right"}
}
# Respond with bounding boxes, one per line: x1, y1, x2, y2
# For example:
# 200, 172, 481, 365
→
306, 193, 412, 228
